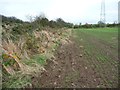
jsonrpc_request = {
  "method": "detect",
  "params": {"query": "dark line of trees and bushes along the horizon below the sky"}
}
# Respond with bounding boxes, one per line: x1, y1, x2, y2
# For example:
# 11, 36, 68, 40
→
0, 15, 118, 28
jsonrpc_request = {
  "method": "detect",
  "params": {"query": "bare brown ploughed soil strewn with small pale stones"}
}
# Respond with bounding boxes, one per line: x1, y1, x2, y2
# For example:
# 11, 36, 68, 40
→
32, 32, 118, 88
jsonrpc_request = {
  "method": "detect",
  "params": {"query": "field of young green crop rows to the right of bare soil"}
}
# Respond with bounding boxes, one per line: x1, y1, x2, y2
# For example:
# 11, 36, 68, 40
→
73, 28, 118, 87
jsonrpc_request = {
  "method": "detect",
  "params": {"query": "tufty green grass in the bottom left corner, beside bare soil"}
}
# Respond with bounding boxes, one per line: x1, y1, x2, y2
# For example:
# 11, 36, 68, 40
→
2, 73, 31, 88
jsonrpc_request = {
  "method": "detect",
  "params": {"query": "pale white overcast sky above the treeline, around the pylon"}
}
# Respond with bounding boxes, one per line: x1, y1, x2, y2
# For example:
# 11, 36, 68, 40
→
0, 0, 119, 24
